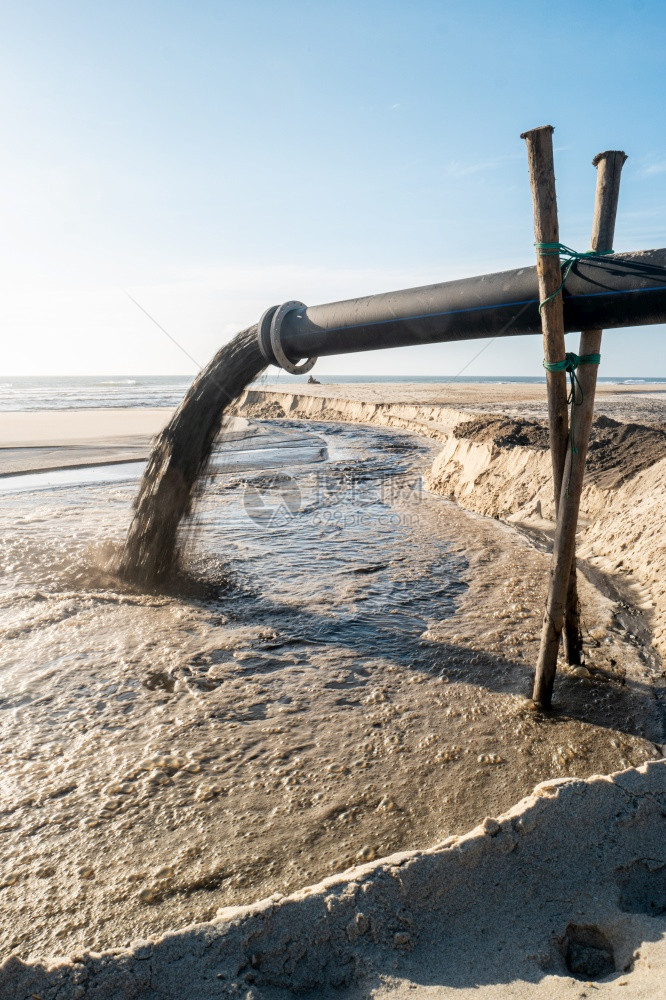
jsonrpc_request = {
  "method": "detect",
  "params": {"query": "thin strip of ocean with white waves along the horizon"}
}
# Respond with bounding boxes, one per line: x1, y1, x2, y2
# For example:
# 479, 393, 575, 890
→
0, 368, 666, 411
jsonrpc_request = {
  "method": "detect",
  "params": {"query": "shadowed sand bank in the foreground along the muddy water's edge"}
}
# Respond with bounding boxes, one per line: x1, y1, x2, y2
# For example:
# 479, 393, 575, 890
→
0, 763, 666, 1000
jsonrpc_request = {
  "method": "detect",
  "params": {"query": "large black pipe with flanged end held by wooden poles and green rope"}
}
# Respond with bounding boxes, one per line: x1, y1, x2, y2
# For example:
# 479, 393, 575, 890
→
260, 249, 666, 364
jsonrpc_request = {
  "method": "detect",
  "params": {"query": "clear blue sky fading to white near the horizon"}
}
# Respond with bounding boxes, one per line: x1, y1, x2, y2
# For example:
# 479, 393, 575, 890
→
0, 0, 666, 376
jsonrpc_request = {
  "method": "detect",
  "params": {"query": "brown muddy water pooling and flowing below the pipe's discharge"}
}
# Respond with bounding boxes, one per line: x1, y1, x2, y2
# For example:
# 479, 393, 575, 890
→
0, 422, 661, 958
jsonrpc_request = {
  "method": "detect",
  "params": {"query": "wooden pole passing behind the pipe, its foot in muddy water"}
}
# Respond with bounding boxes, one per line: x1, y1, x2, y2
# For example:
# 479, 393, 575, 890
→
532, 150, 627, 708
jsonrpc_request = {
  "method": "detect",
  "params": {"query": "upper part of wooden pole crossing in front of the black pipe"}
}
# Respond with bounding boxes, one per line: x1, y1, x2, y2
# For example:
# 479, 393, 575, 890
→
520, 125, 569, 511
